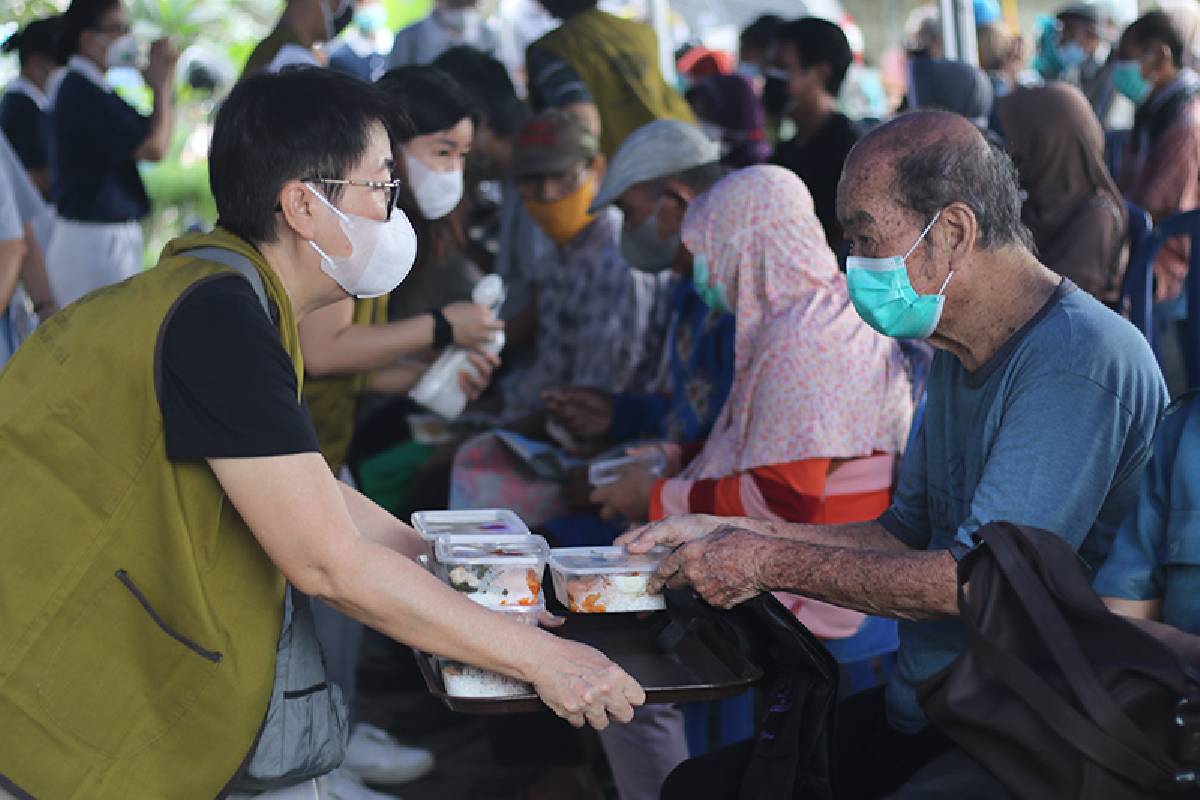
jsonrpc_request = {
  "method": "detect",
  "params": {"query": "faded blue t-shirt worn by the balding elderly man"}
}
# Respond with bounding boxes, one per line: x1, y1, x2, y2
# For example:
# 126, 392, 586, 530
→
880, 279, 1168, 732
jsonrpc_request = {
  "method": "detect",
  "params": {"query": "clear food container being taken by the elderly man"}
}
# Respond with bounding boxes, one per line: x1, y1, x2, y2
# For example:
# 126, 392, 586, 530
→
550, 547, 668, 614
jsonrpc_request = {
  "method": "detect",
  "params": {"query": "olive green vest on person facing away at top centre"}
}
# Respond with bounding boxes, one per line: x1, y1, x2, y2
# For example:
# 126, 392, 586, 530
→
532, 8, 696, 158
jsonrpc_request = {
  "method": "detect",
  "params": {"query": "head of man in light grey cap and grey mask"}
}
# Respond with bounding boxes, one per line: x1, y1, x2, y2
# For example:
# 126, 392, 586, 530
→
590, 120, 725, 272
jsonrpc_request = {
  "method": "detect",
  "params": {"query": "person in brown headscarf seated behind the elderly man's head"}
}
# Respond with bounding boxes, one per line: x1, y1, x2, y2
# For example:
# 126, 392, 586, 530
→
996, 82, 1128, 307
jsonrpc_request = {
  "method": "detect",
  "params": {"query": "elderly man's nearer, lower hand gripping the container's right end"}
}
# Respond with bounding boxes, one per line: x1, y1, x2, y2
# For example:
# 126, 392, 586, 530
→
647, 525, 779, 608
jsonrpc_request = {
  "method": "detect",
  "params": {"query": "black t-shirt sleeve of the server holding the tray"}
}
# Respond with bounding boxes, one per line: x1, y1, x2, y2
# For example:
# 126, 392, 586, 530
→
158, 275, 319, 461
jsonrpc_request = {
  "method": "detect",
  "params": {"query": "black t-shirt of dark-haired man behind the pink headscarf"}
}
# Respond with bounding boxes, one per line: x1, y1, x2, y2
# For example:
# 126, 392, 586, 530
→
770, 114, 863, 254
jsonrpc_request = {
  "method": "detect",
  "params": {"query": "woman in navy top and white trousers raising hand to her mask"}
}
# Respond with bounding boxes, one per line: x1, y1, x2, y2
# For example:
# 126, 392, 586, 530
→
46, 0, 179, 306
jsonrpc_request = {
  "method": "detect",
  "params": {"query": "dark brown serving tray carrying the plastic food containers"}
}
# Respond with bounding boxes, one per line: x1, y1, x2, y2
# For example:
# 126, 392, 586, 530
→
416, 612, 762, 714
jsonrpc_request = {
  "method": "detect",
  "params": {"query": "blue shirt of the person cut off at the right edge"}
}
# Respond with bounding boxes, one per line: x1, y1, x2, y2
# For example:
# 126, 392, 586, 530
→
1094, 393, 1200, 634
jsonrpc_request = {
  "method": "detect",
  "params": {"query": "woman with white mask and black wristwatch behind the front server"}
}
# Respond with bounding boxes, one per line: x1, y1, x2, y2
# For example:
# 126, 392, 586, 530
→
300, 67, 503, 473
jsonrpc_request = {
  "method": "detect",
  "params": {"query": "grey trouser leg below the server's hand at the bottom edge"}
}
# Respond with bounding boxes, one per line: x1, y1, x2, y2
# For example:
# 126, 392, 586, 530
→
600, 705, 688, 800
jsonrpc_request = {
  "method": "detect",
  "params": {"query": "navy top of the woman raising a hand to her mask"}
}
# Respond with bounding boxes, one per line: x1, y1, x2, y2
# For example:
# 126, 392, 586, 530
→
50, 70, 150, 222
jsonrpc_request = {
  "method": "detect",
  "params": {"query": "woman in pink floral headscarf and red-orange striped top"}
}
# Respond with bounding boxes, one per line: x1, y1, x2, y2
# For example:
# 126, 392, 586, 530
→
593, 166, 913, 638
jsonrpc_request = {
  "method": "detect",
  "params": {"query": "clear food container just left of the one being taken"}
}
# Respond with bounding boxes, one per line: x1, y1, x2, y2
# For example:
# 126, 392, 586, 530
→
433, 534, 550, 608
